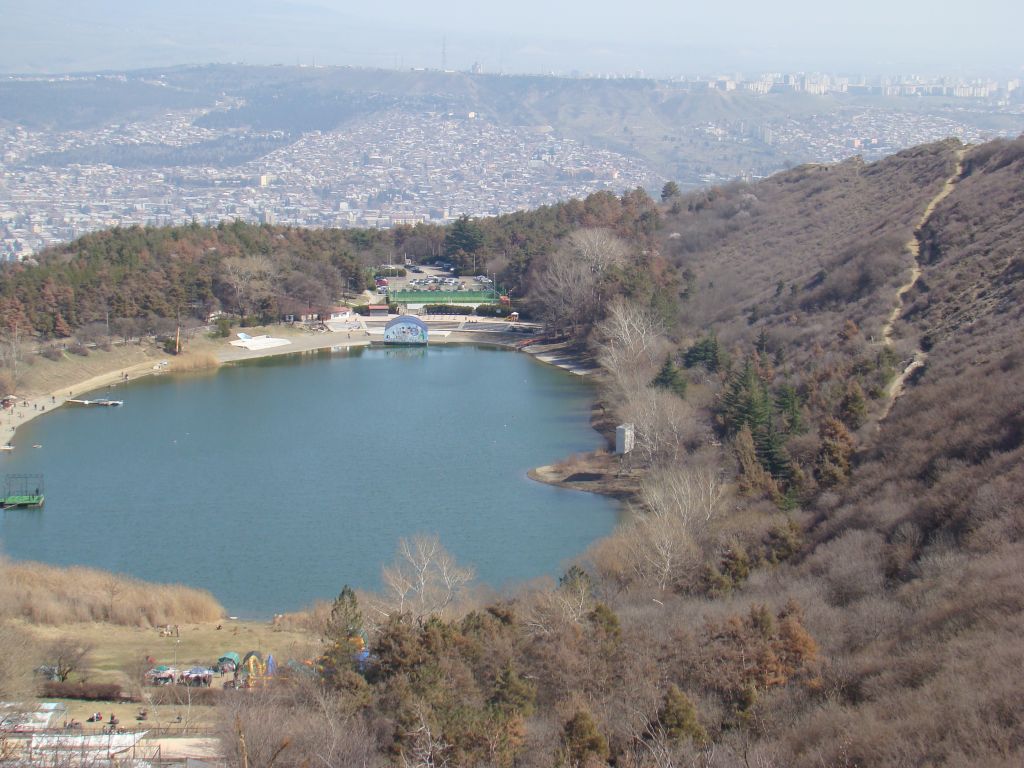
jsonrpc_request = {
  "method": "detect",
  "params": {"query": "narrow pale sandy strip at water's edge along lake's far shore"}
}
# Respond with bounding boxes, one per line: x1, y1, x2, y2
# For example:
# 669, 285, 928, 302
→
0, 316, 561, 444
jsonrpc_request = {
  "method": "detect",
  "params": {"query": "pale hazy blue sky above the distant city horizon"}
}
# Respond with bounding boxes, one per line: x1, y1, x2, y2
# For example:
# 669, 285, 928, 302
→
0, 0, 1024, 76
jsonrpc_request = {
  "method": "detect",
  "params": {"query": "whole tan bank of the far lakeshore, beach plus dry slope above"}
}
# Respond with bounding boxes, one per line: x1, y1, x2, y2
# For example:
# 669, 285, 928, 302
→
0, 315, 577, 445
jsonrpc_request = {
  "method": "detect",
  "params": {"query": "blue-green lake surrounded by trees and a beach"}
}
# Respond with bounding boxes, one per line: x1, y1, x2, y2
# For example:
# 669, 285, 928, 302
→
0, 345, 621, 617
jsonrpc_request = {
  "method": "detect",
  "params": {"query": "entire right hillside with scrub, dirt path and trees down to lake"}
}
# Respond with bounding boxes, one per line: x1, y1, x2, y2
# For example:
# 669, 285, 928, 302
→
2, 138, 1024, 768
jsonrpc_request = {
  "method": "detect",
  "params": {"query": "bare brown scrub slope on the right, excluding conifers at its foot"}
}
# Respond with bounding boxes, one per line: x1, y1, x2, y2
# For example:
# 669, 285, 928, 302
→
577, 140, 1024, 765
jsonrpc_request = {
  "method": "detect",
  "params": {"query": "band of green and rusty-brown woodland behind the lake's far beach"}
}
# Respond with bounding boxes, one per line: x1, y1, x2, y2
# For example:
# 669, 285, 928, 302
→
0, 190, 657, 340
